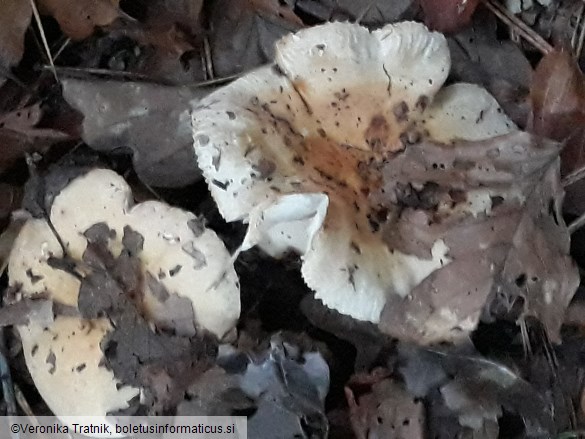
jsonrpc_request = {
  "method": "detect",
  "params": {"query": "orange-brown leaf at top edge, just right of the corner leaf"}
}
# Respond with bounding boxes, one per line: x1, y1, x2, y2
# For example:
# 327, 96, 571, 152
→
37, 0, 120, 40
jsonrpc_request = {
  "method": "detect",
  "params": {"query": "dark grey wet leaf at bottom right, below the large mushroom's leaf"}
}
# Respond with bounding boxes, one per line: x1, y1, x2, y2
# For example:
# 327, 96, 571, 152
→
400, 346, 555, 437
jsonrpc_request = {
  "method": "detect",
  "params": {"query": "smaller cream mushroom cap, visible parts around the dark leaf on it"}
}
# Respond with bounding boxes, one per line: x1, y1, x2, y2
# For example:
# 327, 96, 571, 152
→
8, 169, 240, 419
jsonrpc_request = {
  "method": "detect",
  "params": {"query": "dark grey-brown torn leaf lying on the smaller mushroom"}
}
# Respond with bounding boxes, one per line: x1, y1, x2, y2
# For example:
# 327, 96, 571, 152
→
53, 223, 217, 415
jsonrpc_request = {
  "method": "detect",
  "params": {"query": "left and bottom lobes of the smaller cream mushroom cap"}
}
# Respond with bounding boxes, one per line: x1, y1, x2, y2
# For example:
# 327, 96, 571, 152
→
8, 219, 139, 426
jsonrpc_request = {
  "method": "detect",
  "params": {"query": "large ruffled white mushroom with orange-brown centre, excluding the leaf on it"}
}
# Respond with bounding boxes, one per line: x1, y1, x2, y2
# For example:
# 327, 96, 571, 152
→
192, 22, 516, 323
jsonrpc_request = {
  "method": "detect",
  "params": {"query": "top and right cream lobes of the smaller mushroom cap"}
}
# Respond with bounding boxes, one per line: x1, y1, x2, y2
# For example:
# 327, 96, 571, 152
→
51, 169, 240, 338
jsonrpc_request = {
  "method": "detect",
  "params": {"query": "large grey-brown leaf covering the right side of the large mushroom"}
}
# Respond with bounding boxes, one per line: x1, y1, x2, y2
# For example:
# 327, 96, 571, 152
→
379, 132, 579, 344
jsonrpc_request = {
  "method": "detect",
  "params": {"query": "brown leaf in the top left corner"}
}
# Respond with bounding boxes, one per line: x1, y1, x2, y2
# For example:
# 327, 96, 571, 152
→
0, 0, 31, 80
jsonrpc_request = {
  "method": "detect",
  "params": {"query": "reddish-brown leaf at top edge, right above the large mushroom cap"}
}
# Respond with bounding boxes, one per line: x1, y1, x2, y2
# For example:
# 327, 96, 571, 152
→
420, 0, 479, 33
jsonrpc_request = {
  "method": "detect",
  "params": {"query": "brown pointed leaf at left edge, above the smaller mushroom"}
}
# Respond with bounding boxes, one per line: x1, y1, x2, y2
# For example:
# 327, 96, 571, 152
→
0, 104, 70, 172
